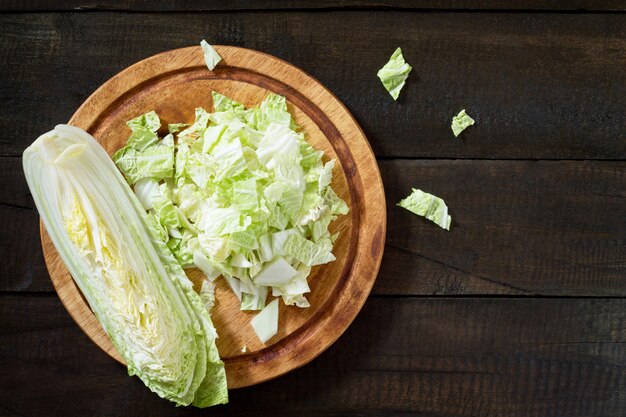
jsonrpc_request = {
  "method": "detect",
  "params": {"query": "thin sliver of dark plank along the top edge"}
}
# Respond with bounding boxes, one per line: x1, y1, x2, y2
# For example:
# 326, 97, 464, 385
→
0, 0, 626, 12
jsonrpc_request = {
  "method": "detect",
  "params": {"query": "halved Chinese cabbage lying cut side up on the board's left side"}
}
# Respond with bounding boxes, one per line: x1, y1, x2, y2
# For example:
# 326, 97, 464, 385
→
23, 126, 228, 407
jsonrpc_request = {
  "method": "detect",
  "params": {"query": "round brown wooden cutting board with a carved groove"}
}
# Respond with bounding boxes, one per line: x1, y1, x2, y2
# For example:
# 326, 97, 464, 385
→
41, 46, 386, 388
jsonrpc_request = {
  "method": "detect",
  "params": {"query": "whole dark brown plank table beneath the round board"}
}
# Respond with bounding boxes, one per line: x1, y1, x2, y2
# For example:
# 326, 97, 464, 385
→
0, 0, 626, 417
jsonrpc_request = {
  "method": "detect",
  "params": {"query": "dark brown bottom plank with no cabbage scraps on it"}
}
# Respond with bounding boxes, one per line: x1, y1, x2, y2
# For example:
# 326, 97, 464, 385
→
0, 296, 626, 417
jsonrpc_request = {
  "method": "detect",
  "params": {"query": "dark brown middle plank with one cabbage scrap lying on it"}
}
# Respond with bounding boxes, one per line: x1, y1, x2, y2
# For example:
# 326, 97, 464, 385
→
0, 158, 626, 296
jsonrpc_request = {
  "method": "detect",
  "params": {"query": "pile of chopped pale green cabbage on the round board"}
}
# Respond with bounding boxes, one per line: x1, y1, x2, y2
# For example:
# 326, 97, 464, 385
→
113, 92, 348, 326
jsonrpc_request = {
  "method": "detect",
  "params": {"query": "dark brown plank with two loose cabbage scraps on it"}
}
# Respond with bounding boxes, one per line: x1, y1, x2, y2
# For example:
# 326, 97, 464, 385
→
0, 11, 626, 159
